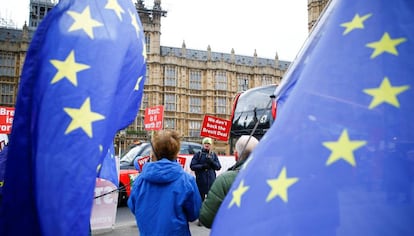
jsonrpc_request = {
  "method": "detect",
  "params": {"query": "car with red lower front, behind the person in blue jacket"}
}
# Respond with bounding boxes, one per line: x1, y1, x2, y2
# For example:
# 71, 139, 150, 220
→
118, 141, 203, 206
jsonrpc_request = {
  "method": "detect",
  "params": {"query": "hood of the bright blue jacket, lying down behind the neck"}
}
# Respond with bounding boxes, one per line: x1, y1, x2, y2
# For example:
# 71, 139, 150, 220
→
140, 158, 184, 183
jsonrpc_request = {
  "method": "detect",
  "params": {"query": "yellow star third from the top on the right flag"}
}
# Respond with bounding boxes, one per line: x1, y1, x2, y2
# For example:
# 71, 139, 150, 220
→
364, 77, 410, 109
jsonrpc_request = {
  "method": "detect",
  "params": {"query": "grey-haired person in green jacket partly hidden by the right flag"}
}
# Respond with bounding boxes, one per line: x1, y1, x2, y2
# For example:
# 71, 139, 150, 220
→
199, 135, 259, 228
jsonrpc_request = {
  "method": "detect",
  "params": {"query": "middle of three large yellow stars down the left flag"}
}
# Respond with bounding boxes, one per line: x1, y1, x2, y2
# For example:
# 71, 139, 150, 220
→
50, 50, 90, 86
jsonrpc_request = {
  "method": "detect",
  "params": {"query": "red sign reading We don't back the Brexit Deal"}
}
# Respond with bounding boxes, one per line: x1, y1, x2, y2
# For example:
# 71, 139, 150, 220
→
200, 115, 231, 141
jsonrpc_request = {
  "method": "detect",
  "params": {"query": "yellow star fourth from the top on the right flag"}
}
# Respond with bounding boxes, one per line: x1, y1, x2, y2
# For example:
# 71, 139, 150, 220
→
322, 129, 367, 166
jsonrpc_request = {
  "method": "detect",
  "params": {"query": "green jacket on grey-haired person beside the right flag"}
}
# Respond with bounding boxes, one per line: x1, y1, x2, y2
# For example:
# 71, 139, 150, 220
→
199, 163, 243, 228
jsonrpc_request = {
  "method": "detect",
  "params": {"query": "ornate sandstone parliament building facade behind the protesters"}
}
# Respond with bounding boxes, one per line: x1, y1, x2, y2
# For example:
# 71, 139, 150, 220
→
0, 0, 328, 154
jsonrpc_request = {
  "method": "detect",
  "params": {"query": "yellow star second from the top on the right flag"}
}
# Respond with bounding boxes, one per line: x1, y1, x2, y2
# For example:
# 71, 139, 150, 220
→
367, 32, 407, 59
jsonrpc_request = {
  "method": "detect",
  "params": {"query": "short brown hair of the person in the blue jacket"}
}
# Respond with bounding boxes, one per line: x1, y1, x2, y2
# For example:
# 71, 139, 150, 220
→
152, 130, 181, 161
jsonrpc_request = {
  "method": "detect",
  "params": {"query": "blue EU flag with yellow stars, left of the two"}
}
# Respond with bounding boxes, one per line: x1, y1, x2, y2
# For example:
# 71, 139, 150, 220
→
0, 0, 146, 236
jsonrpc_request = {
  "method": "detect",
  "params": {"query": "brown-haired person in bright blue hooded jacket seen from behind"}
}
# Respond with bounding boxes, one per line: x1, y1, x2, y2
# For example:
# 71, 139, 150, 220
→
128, 131, 201, 236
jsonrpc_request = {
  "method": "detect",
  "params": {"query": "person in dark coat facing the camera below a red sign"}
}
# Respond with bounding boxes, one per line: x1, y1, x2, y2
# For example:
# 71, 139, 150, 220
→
190, 138, 221, 201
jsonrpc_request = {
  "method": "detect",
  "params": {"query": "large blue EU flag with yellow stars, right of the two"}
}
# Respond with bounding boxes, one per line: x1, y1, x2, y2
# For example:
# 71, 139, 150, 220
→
211, 0, 414, 236
